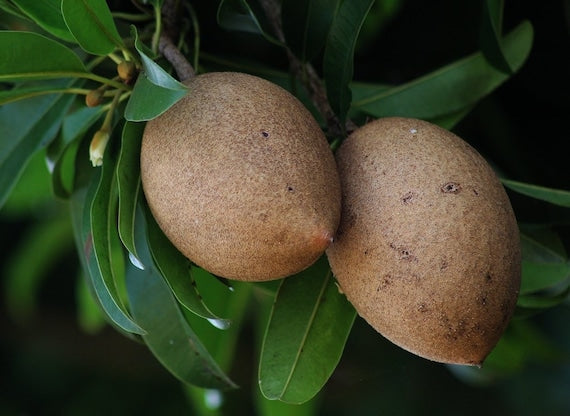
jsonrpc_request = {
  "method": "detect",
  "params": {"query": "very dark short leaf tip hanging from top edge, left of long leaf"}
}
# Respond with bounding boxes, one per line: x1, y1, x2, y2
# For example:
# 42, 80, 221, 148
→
281, 0, 340, 62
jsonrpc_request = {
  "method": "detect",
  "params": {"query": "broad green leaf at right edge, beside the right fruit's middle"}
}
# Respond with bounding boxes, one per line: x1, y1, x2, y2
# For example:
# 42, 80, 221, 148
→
520, 234, 570, 295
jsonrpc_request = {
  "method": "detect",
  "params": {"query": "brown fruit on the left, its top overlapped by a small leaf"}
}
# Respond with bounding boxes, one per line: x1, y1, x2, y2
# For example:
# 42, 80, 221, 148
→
141, 72, 340, 281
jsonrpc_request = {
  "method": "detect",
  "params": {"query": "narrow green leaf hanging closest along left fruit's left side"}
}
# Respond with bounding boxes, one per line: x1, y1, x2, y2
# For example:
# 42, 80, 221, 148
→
117, 122, 144, 258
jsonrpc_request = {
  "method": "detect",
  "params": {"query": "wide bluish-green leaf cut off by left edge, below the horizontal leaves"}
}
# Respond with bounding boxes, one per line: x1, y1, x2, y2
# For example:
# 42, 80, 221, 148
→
0, 90, 73, 207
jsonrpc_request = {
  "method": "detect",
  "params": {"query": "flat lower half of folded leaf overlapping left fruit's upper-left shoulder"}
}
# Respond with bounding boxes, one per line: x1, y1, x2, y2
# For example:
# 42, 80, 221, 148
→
125, 73, 188, 121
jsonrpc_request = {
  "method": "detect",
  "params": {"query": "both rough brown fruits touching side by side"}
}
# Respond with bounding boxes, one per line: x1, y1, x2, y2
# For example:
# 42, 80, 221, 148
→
141, 73, 520, 365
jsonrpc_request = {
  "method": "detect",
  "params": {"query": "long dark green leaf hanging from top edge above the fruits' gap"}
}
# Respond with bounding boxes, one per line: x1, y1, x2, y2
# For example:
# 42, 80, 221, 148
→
323, 0, 374, 124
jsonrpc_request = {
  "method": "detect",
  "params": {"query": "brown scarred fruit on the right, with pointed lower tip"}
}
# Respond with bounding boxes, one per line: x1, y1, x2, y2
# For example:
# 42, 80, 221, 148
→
327, 118, 521, 365
